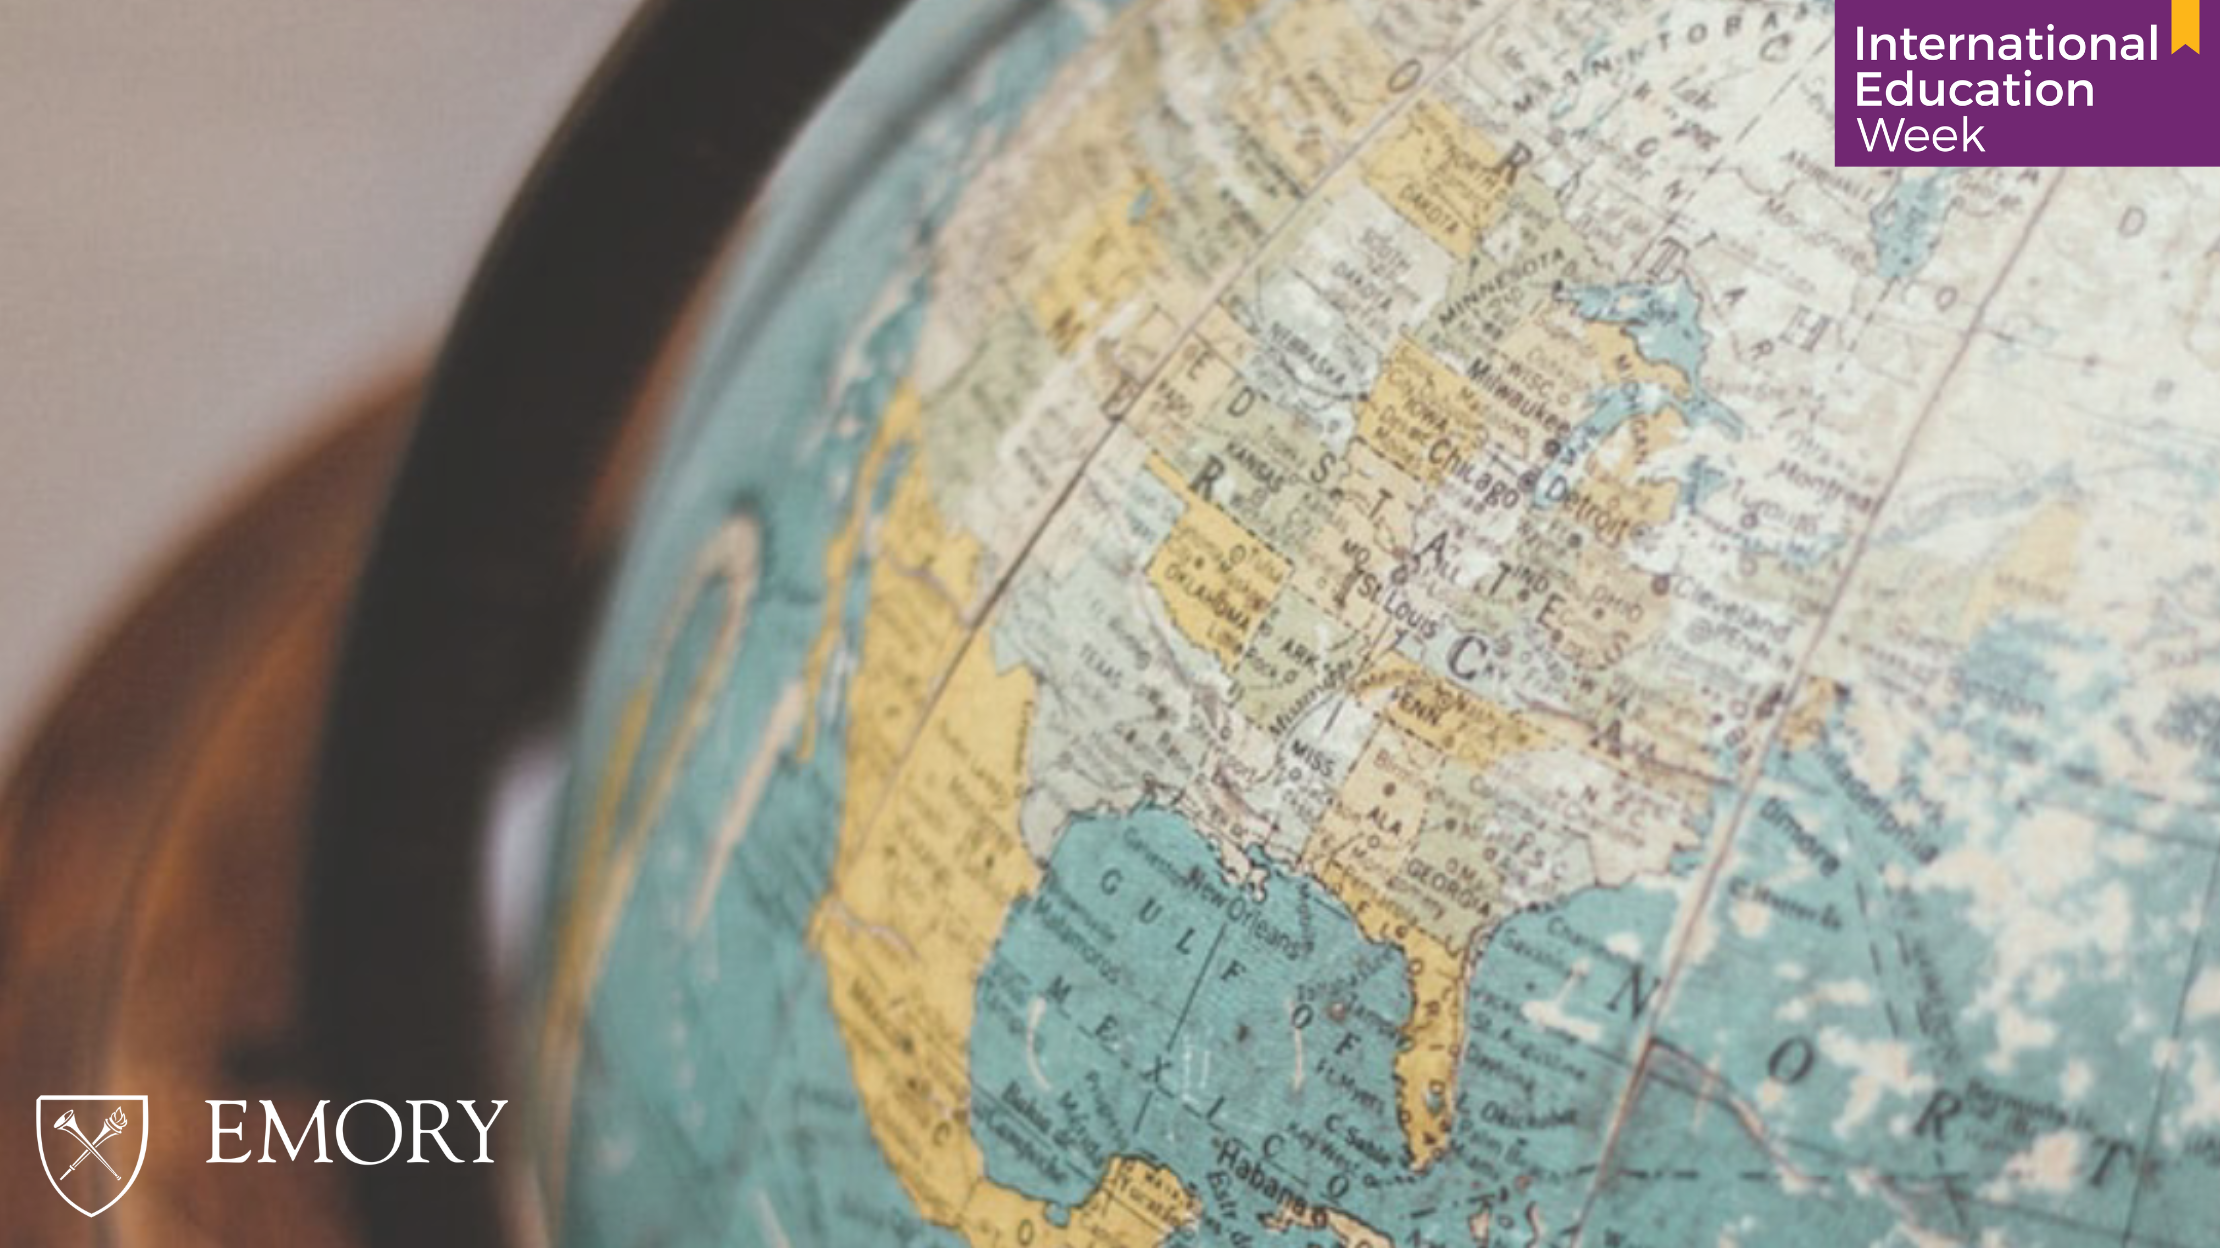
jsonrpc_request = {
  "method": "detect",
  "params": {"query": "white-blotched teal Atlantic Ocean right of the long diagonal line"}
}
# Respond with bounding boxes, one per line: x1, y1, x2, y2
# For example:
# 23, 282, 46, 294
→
1616, 615, 2211, 1246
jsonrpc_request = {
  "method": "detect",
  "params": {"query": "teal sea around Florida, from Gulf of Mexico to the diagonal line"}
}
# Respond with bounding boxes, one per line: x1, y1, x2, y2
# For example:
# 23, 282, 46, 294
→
972, 806, 1672, 1248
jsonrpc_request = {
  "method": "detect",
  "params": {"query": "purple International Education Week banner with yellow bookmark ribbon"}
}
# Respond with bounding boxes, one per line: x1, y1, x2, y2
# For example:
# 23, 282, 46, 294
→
1834, 0, 2220, 167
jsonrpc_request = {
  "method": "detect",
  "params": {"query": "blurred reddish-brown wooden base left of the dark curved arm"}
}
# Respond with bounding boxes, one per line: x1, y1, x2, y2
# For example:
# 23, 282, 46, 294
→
0, 384, 415, 1248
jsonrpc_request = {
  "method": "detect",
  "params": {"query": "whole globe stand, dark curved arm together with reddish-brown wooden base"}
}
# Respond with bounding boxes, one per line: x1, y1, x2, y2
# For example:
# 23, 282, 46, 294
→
0, 0, 899, 1248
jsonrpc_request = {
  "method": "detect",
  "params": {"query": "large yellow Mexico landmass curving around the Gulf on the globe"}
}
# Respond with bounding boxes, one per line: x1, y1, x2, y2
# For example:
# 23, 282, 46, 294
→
810, 424, 1194, 1248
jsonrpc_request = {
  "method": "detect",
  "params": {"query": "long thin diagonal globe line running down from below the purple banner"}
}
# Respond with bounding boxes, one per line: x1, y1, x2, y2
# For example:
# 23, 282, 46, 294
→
1570, 169, 2071, 1248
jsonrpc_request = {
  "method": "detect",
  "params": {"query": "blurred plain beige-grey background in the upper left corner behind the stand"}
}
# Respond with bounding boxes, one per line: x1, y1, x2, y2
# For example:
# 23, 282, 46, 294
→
0, 0, 633, 759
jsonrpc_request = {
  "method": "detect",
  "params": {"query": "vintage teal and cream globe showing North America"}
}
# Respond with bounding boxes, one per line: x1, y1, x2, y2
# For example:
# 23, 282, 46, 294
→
513, 0, 2220, 1248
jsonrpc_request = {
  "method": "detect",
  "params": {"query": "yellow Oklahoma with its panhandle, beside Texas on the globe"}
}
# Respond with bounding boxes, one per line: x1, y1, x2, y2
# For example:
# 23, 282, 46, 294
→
1148, 455, 1288, 671
